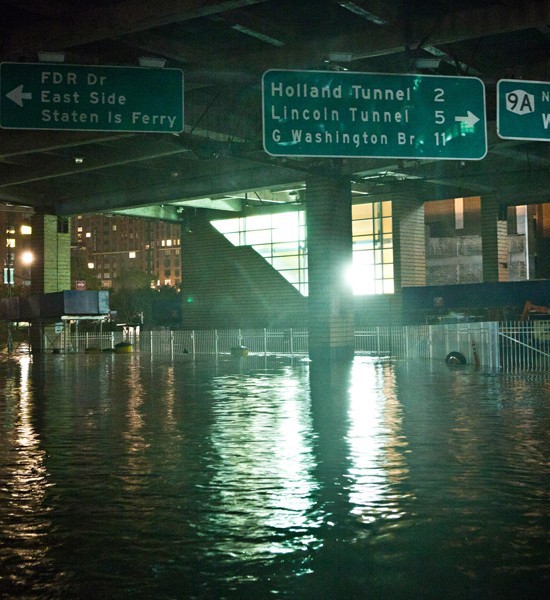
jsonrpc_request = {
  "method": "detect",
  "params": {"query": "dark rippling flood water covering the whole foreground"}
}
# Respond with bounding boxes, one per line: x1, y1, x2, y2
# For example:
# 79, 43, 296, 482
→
0, 354, 550, 600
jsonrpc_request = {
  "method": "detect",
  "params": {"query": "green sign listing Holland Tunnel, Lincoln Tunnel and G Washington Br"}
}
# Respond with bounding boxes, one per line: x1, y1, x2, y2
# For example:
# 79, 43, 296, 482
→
262, 70, 487, 160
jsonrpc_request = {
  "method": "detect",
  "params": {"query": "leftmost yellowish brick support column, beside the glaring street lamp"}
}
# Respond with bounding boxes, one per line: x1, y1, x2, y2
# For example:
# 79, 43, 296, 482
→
30, 213, 71, 353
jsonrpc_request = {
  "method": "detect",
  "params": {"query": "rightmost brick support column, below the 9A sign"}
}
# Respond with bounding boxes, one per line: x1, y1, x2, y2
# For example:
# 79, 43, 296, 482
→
481, 196, 510, 283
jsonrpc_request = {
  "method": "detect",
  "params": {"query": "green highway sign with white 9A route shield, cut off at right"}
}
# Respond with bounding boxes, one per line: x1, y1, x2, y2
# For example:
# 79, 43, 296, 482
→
497, 79, 550, 142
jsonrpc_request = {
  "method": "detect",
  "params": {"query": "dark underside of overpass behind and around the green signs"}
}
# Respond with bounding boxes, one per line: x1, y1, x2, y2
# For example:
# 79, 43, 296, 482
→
0, 0, 550, 215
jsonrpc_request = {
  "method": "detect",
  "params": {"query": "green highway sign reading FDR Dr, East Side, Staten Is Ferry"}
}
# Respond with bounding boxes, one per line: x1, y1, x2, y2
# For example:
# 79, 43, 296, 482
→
0, 63, 183, 133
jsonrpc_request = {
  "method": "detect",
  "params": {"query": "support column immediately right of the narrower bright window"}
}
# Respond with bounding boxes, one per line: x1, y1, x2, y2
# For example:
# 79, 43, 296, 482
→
391, 193, 426, 322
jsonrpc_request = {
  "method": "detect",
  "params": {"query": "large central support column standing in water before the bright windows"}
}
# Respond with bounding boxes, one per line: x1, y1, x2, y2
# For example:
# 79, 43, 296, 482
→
306, 176, 355, 361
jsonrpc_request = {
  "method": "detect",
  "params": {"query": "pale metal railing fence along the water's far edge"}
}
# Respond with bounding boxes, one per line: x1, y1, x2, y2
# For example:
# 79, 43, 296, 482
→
40, 321, 550, 371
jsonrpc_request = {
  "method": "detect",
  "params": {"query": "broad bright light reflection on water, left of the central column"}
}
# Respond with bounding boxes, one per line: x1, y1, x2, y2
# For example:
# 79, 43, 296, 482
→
210, 369, 320, 558
